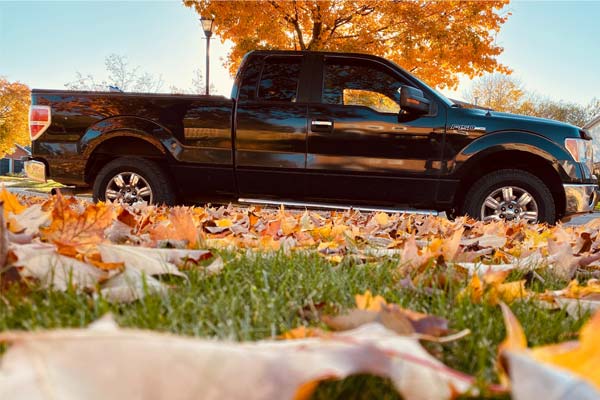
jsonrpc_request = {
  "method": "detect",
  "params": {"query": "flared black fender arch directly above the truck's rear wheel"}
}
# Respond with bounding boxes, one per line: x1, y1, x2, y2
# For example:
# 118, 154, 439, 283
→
79, 117, 174, 159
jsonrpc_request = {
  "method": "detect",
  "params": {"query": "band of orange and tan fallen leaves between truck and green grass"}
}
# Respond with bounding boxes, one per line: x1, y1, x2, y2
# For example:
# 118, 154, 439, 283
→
0, 189, 600, 309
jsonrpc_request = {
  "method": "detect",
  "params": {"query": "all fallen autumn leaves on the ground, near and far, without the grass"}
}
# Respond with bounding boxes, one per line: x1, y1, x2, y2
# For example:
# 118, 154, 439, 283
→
0, 190, 600, 399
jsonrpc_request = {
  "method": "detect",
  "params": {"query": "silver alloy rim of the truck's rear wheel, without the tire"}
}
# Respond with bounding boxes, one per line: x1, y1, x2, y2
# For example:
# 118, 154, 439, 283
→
105, 171, 153, 204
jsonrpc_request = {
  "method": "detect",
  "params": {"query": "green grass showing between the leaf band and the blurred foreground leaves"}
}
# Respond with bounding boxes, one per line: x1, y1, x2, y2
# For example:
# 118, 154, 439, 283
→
0, 253, 585, 399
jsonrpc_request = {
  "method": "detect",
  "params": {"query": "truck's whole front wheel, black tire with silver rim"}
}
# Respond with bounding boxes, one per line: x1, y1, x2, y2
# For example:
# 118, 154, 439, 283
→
462, 169, 556, 224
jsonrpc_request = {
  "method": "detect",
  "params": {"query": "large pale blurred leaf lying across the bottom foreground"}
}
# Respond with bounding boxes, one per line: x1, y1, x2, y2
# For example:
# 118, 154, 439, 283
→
0, 322, 474, 400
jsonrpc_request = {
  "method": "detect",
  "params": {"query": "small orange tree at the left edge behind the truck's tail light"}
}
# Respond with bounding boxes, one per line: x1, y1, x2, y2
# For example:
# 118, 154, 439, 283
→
0, 77, 30, 157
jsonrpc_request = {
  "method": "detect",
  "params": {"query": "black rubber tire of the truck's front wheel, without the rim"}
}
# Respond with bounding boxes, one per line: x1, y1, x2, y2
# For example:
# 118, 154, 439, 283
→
462, 169, 556, 224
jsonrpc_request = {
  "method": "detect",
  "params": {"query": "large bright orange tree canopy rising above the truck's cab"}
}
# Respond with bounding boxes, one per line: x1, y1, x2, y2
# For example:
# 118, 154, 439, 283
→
183, 0, 509, 88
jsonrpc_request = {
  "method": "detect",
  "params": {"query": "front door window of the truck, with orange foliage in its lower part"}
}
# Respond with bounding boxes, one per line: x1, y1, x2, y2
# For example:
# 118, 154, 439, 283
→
322, 59, 403, 114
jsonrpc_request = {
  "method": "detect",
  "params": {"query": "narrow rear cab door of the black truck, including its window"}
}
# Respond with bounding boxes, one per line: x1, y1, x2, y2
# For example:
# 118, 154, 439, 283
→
235, 53, 308, 198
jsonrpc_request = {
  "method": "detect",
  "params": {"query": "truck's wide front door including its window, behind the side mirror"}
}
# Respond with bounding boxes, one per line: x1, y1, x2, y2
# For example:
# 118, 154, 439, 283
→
306, 56, 445, 206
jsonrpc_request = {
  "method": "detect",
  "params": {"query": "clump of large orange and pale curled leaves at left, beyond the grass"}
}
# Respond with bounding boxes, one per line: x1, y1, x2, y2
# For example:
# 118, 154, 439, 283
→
0, 189, 223, 302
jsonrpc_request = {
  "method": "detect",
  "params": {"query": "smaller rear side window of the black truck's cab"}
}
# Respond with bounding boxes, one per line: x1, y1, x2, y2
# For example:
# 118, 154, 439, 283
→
258, 57, 302, 102
